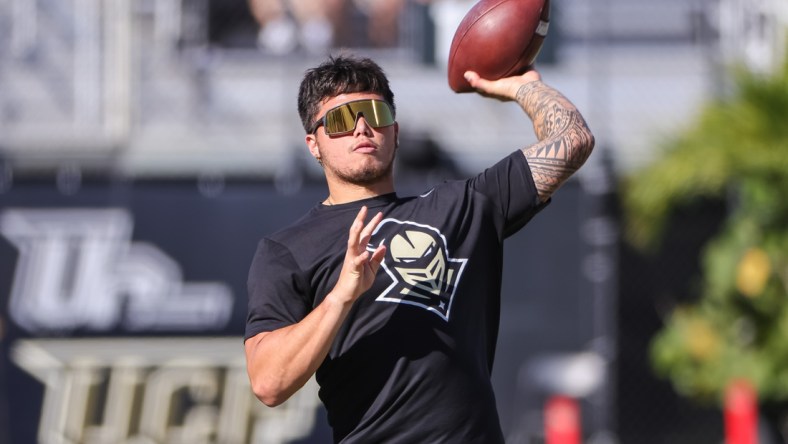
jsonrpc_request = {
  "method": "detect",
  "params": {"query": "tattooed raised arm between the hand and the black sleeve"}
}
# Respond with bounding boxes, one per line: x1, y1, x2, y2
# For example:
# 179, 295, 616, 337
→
516, 81, 594, 201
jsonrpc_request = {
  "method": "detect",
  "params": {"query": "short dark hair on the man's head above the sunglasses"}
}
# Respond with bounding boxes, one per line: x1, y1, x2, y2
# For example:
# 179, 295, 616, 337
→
298, 54, 397, 133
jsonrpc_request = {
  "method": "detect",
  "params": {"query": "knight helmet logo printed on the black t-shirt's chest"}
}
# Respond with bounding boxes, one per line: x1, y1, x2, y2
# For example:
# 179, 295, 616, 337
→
368, 219, 467, 322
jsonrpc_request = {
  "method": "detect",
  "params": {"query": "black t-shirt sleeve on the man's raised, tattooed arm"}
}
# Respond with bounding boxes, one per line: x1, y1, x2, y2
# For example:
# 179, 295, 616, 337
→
469, 150, 550, 237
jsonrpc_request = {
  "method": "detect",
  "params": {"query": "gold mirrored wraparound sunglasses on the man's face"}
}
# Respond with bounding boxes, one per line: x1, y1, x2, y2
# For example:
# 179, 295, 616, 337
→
309, 99, 394, 136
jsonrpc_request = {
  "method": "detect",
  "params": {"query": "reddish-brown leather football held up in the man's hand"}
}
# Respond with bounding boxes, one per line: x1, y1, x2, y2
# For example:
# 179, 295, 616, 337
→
448, 0, 550, 93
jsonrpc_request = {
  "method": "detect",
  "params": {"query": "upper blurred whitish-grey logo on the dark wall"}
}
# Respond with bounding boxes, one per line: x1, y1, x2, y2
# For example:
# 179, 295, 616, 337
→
0, 208, 233, 334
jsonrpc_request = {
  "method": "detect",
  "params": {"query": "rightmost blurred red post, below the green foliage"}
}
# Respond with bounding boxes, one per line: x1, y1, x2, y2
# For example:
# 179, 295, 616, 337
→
725, 380, 758, 444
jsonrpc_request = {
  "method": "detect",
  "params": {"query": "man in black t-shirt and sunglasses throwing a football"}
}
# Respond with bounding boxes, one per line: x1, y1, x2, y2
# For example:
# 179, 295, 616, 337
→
245, 53, 594, 444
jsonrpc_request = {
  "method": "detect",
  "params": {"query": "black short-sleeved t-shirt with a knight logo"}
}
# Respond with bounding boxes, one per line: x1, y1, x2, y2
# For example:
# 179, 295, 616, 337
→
245, 151, 544, 444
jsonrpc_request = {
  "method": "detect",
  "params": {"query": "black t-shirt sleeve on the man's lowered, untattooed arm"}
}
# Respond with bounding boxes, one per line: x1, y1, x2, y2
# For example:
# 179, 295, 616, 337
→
244, 239, 312, 339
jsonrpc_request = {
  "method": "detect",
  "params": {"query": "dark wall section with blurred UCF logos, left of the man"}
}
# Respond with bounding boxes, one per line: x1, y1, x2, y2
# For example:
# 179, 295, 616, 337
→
0, 185, 330, 444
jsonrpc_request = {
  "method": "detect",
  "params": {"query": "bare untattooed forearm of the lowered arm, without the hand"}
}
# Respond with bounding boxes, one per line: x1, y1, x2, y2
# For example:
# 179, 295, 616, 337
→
245, 294, 352, 407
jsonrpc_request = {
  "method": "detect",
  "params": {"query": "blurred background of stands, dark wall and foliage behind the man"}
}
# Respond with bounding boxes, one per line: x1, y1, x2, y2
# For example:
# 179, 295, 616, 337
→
0, 0, 788, 444
